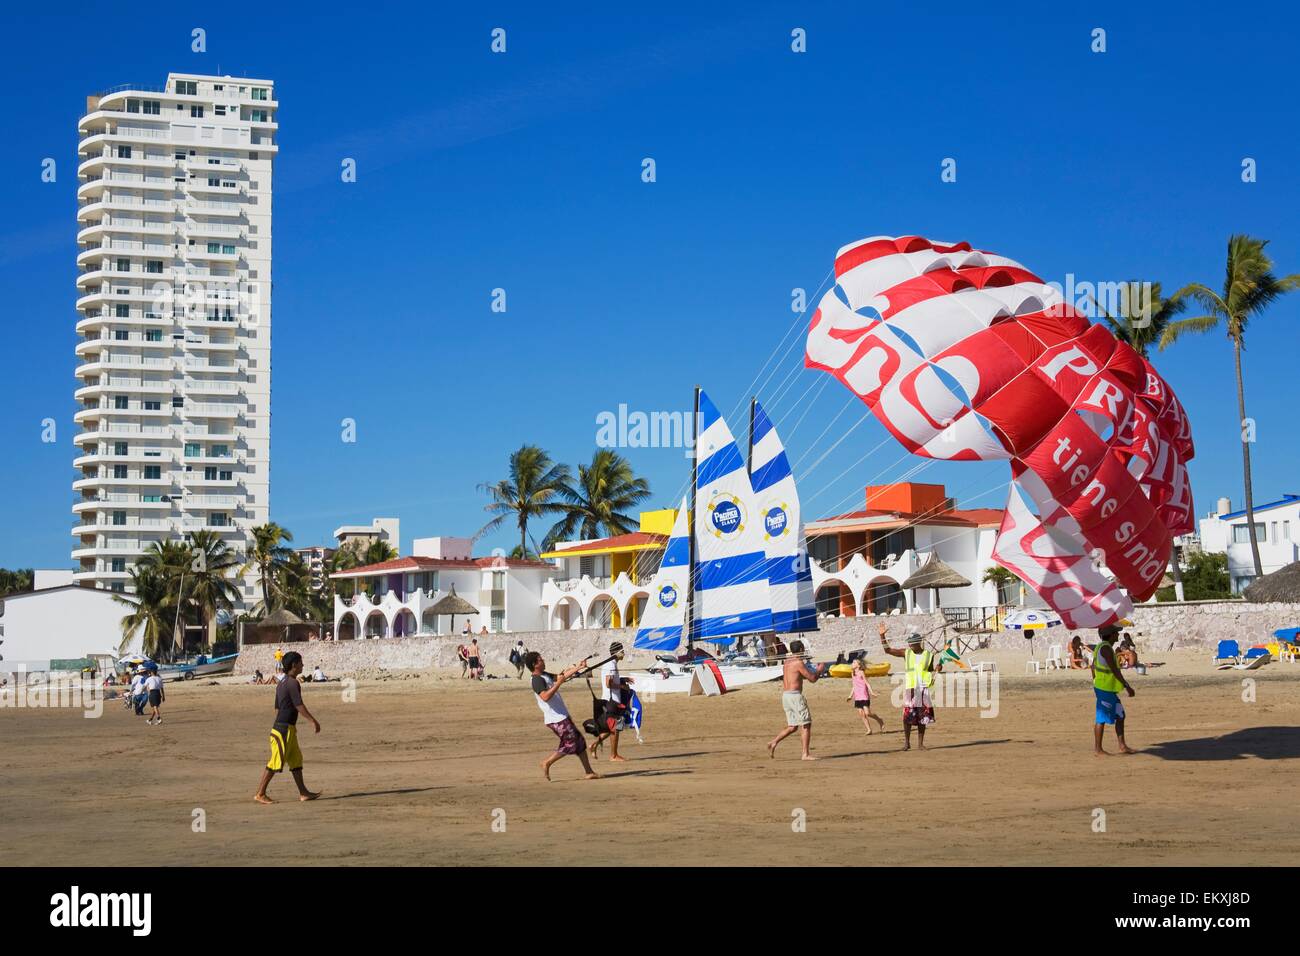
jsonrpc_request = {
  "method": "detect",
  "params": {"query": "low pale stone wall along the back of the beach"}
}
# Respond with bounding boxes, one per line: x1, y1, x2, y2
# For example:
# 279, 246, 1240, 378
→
235, 601, 1300, 676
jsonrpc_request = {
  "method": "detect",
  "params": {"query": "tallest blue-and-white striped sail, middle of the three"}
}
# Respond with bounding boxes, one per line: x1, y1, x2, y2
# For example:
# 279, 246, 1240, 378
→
690, 392, 772, 644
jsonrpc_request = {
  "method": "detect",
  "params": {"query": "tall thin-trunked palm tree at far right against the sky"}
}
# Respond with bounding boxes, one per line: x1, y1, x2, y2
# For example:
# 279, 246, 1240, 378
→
1160, 235, 1300, 578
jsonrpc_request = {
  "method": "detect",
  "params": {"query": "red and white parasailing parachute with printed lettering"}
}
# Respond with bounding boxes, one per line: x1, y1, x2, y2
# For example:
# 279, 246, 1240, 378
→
805, 235, 1193, 628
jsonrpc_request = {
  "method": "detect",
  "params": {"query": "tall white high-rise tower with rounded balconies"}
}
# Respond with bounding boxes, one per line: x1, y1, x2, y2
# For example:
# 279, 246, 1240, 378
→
73, 73, 278, 604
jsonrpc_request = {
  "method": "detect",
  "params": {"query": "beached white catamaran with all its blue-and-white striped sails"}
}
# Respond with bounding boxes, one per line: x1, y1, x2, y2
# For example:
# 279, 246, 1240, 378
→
628, 388, 816, 696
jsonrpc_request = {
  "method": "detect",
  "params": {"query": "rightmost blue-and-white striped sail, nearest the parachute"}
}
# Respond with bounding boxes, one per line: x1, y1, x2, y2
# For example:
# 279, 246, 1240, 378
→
749, 402, 816, 633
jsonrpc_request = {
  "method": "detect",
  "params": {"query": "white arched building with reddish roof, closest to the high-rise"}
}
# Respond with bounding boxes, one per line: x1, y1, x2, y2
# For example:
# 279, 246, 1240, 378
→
330, 537, 555, 640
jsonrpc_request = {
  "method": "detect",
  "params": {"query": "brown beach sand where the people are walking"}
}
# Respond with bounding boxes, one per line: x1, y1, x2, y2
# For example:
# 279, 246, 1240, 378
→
0, 652, 1300, 866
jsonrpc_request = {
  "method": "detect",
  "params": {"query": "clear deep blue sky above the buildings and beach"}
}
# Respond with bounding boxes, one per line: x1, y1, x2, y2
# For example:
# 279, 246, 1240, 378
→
0, 3, 1300, 567
